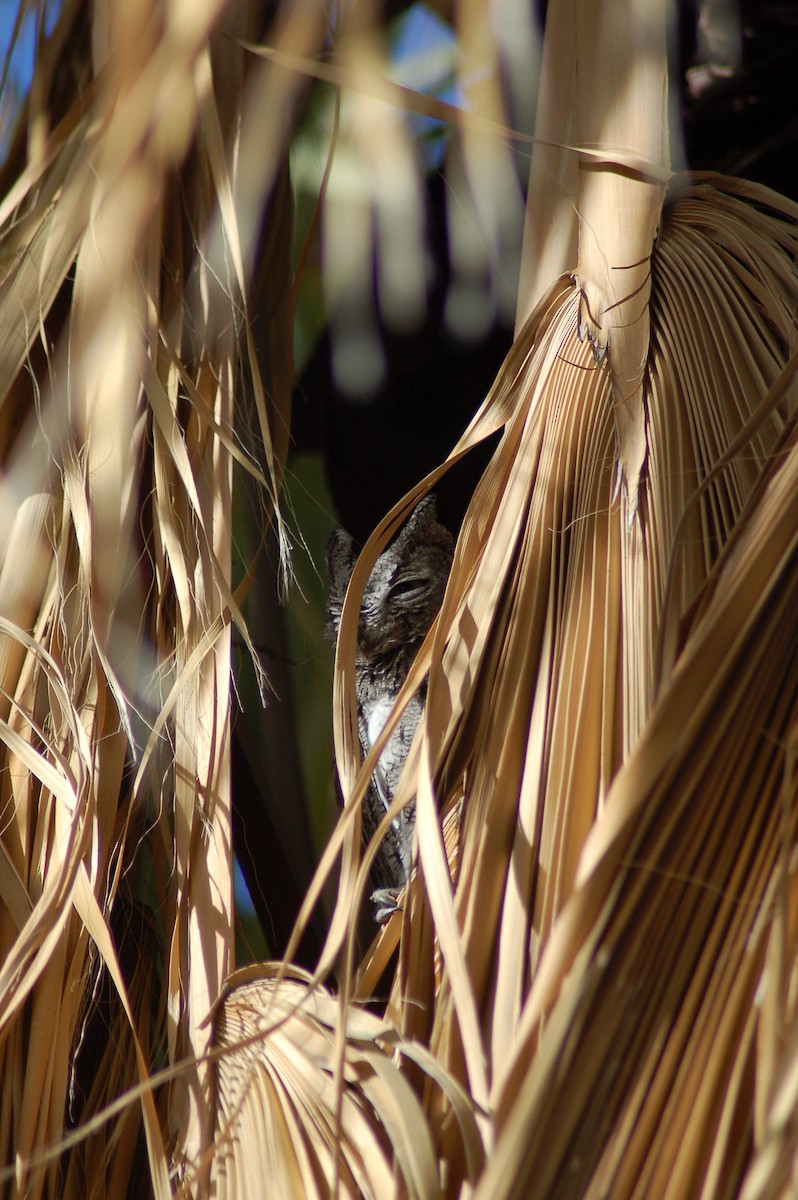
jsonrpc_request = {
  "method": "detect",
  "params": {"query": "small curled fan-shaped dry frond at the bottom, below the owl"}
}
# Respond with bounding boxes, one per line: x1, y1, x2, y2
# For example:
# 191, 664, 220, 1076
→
206, 968, 481, 1198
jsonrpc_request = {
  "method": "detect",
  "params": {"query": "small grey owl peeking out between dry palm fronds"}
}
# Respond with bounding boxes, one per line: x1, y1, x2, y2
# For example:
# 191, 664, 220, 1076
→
326, 496, 454, 923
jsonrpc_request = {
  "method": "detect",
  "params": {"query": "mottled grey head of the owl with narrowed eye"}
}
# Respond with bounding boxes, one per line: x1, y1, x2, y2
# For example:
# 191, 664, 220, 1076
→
359, 496, 454, 656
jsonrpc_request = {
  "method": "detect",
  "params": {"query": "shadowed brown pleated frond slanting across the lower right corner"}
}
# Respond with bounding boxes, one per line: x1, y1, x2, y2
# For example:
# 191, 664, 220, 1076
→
472, 340, 798, 1195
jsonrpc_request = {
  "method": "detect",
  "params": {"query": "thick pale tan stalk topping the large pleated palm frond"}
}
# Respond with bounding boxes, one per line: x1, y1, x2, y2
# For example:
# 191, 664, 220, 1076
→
518, 0, 671, 515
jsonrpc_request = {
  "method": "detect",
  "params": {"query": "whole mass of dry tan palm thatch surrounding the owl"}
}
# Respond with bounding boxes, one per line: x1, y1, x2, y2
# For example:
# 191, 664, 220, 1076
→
0, 2, 798, 1198
